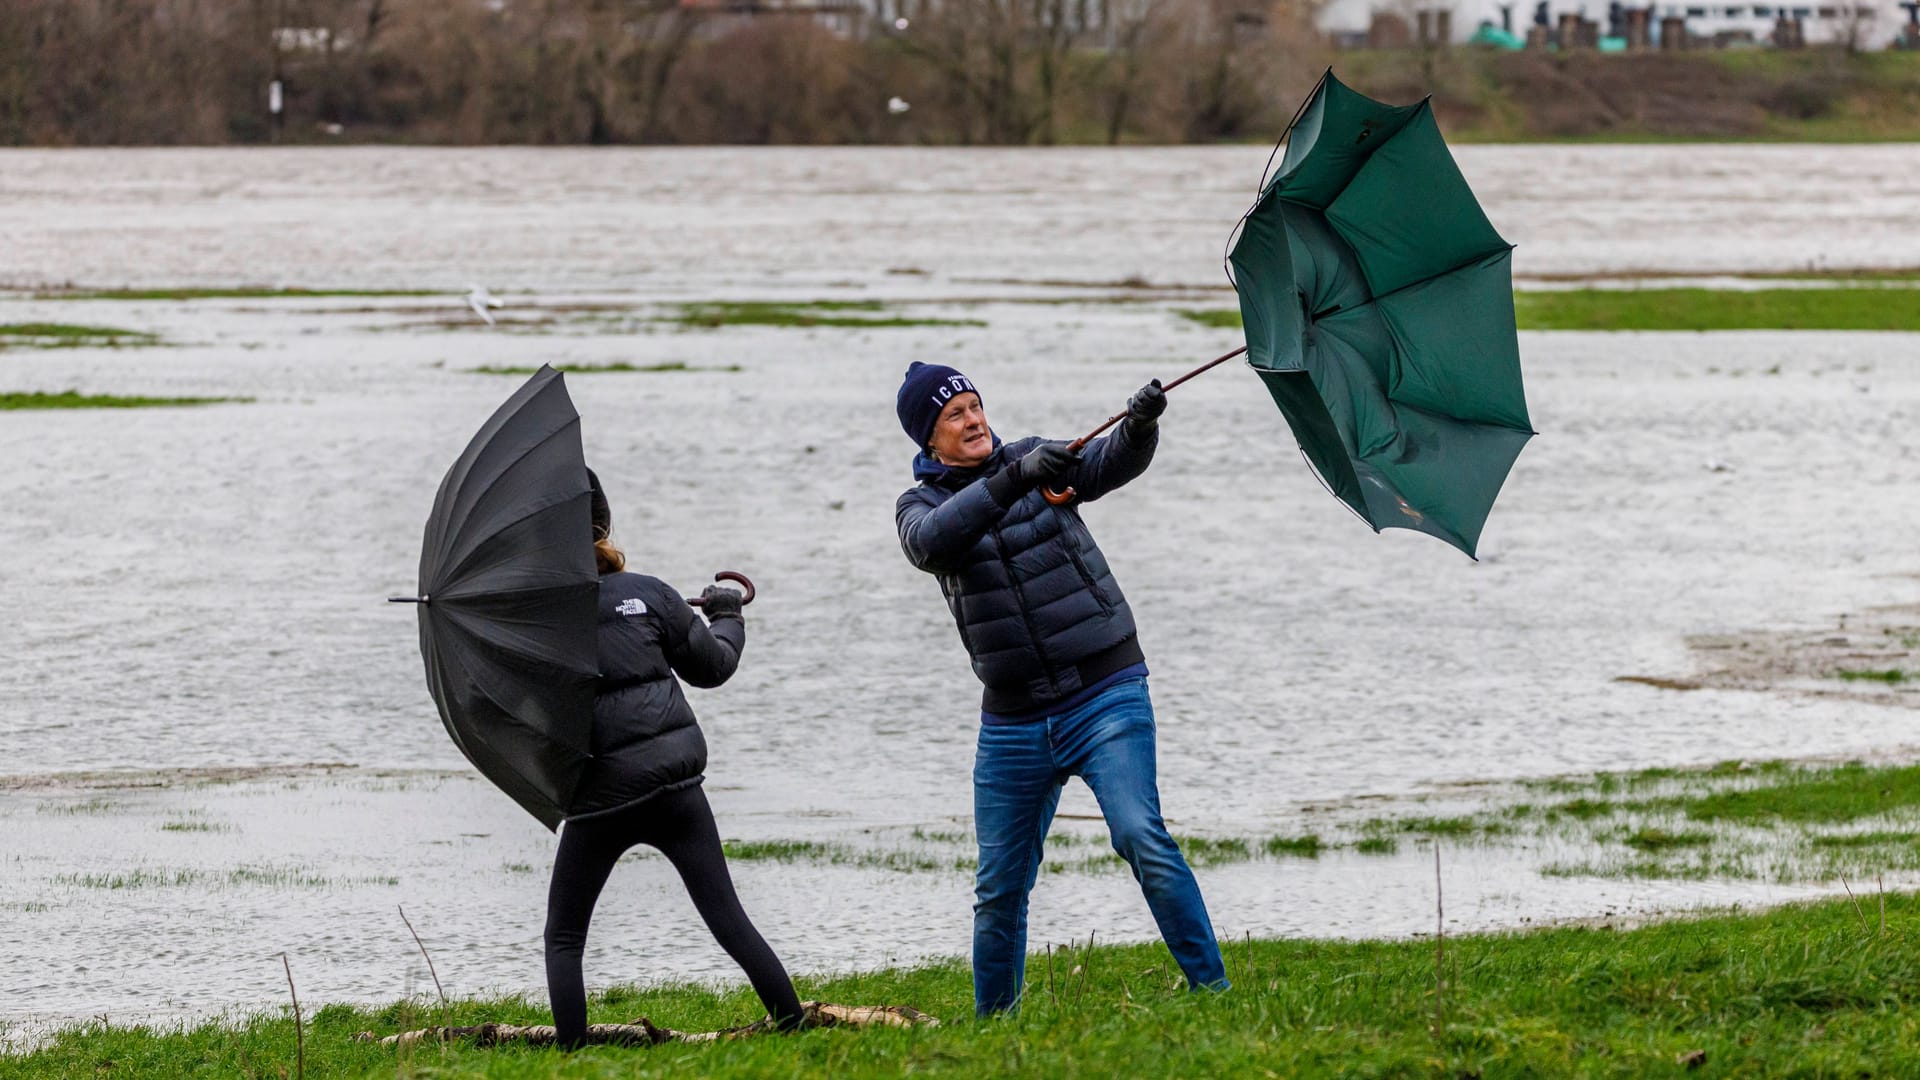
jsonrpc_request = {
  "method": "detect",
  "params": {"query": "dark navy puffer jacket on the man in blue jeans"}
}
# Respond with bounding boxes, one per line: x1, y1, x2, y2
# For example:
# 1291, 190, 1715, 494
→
895, 421, 1158, 715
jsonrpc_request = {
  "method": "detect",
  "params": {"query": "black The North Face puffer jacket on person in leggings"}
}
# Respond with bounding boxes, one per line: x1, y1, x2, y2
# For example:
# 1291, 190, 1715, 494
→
568, 573, 747, 819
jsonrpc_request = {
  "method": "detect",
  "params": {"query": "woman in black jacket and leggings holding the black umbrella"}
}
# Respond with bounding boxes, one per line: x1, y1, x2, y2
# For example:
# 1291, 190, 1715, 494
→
547, 469, 801, 1047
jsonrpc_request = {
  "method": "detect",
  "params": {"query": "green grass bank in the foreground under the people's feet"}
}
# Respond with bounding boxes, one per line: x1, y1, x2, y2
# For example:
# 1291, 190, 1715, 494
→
15, 894, 1920, 1080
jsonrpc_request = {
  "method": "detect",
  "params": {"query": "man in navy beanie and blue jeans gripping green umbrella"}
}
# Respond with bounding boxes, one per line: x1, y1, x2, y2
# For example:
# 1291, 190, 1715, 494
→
895, 363, 1227, 1015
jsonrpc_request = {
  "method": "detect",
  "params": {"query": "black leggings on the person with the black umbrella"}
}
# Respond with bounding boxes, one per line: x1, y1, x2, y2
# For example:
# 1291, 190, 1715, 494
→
547, 784, 801, 1045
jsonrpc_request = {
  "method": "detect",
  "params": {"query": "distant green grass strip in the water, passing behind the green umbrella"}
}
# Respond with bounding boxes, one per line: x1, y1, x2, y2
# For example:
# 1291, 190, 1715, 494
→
1179, 286, 1920, 331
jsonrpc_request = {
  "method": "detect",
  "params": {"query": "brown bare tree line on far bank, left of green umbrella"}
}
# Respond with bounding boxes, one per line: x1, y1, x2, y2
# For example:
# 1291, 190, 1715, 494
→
0, 0, 1351, 146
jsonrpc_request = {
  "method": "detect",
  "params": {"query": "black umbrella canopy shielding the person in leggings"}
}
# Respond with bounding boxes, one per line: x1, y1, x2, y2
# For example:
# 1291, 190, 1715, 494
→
419, 367, 599, 828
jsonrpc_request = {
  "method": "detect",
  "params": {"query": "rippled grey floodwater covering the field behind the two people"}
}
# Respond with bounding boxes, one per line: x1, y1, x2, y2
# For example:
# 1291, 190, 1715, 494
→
0, 146, 1920, 1024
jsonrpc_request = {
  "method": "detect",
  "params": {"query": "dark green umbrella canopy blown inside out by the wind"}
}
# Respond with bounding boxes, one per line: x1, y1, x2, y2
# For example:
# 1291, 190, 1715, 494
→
1229, 71, 1534, 555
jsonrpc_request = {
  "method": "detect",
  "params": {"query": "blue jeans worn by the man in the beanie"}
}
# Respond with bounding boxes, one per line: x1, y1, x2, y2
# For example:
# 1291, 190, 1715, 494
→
973, 678, 1227, 1015
